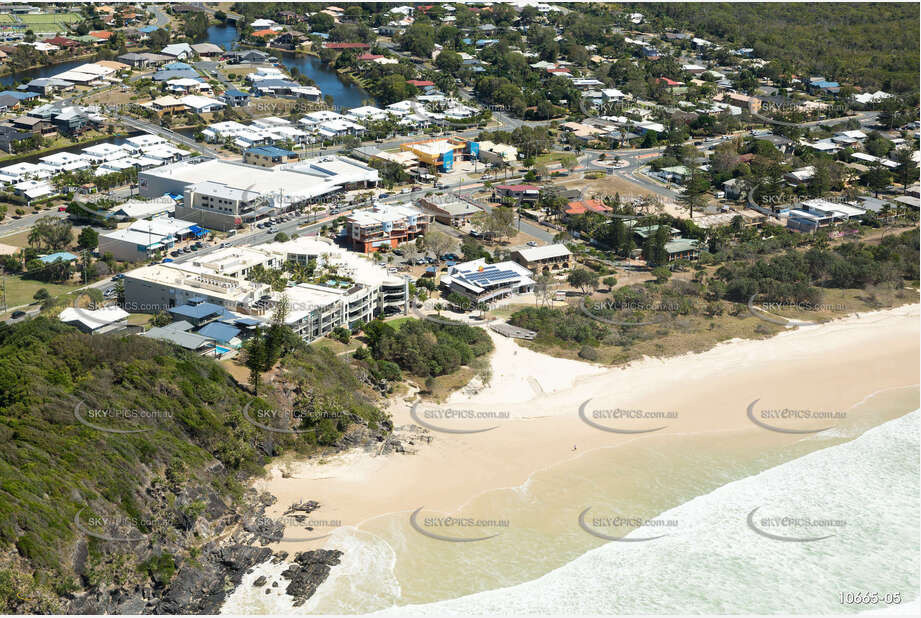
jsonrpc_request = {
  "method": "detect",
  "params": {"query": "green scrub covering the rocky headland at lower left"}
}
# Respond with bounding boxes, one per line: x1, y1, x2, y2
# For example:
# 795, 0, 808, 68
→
0, 317, 389, 613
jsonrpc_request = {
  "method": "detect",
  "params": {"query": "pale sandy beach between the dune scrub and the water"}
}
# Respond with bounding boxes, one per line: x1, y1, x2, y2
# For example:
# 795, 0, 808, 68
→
256, 305, 921, 552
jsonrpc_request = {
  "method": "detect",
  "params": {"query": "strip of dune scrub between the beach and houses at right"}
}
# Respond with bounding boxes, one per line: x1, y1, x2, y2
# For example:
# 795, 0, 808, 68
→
509, 229, 919, 364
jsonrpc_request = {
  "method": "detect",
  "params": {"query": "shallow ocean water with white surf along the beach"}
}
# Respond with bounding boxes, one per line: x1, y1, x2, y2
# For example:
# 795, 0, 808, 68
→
222, 387, 921, 614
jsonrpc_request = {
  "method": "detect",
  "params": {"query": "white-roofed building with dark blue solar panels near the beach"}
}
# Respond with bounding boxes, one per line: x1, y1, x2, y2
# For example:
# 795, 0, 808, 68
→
441, 259, 534, 303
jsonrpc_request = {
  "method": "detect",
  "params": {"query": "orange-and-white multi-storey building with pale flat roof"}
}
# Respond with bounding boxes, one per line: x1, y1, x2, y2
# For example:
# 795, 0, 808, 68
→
345, 203, 432, 253
